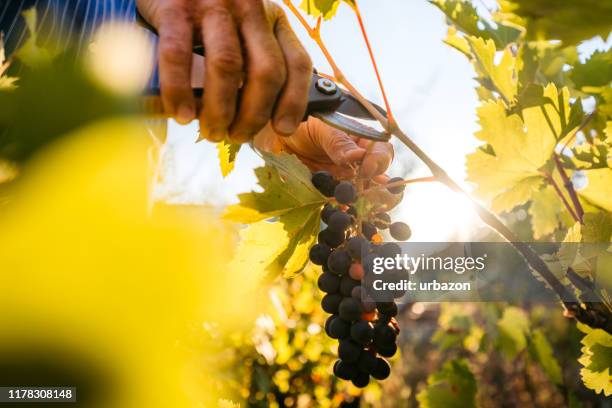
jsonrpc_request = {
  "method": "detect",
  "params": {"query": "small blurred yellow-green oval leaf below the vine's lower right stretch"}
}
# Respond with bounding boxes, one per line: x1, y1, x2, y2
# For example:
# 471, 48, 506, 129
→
497, 306, 529, 359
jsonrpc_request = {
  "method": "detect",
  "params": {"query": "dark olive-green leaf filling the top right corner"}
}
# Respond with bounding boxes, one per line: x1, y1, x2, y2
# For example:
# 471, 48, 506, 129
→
498, 0, 612, 44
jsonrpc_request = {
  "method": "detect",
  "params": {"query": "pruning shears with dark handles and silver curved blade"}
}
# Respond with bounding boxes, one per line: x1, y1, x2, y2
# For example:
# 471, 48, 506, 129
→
137, 15, 390, 142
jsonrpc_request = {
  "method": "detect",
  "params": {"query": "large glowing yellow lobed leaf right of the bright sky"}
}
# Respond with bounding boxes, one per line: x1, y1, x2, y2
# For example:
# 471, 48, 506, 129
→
466, 84, 569, 212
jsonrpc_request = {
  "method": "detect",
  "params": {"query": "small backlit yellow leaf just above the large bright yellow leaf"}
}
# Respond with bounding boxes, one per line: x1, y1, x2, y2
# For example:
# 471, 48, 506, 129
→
467, 36, 517, 104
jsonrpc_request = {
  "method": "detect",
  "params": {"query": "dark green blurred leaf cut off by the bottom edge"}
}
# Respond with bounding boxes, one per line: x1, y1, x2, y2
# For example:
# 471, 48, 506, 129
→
417, 360, 477, 408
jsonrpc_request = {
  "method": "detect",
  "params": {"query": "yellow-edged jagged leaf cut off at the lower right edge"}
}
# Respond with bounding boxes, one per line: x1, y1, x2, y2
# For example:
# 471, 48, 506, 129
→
577, 323, 612, 397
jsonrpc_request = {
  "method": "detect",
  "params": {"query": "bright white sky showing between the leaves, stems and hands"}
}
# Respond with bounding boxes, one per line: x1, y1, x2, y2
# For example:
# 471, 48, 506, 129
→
160, 0, 603, 242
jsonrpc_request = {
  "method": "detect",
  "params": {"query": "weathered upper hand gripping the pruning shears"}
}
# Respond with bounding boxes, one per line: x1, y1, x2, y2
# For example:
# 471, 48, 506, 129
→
136, 0, 312, 143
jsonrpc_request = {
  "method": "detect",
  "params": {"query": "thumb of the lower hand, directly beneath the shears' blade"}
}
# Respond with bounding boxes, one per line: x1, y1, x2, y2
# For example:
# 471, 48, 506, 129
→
310, 120, 366, 167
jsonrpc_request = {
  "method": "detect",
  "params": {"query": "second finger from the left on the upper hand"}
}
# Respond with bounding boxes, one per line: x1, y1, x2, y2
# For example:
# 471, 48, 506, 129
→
198, 0, 244, 142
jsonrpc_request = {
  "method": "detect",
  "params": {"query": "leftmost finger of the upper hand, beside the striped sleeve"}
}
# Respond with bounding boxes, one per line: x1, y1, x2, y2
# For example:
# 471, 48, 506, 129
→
156, 7, 196, 123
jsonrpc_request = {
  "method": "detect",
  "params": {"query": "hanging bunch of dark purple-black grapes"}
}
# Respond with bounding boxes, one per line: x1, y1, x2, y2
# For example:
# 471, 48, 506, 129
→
310, 171, 410, 388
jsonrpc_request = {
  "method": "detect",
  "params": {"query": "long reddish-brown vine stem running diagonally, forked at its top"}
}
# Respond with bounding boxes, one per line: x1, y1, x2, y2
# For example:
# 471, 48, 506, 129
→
283, 0, 612, 334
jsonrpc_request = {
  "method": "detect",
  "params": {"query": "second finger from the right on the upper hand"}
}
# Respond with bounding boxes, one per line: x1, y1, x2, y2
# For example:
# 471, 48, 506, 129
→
230, 0, 287, 143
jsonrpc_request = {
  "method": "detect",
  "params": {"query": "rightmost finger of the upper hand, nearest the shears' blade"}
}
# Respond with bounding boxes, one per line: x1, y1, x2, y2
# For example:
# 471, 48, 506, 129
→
272, 13, 312, 136
